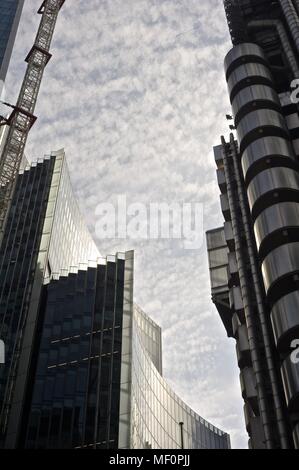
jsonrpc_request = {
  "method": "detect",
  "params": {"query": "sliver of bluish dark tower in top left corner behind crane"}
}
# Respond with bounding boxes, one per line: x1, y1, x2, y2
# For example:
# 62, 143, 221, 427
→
0, 0, 24, 91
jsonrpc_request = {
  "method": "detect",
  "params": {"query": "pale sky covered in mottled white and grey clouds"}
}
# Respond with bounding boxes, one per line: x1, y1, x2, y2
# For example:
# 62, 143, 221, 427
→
6, 0, 248, 448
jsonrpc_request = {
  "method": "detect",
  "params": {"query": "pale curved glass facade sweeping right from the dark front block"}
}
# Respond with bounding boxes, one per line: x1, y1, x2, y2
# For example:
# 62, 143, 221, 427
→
131, 308, 230, 449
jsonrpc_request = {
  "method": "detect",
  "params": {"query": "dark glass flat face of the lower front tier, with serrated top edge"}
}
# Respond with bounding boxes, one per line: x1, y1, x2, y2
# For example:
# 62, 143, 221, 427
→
24, 253, 133, 449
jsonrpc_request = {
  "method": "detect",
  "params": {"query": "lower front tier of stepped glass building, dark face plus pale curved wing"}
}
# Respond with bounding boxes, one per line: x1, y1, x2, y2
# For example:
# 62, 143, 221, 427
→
19, 252, 230, 449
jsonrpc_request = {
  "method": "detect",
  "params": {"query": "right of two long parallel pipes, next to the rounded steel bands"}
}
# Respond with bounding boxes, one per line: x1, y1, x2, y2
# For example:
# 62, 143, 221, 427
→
230, 134, 289, 449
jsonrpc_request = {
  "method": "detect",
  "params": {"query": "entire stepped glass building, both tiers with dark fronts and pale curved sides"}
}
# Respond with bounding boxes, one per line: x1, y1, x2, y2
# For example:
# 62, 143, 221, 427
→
0, 156, 230, 449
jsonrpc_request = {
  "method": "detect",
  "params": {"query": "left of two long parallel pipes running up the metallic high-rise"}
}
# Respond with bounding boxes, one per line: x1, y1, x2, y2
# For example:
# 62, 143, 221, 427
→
221, 137, 274, 449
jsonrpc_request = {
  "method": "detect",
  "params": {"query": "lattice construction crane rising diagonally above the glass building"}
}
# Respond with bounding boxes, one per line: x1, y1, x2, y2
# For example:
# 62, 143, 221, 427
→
0, 0, 65, 232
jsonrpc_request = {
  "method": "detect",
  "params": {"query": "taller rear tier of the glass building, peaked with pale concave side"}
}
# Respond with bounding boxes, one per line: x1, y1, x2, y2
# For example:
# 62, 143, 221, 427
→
0, 151, 99, 446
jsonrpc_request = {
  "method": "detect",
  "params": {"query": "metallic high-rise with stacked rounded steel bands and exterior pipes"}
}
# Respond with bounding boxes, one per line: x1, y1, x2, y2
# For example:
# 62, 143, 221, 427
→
207, 0, 299, 449
